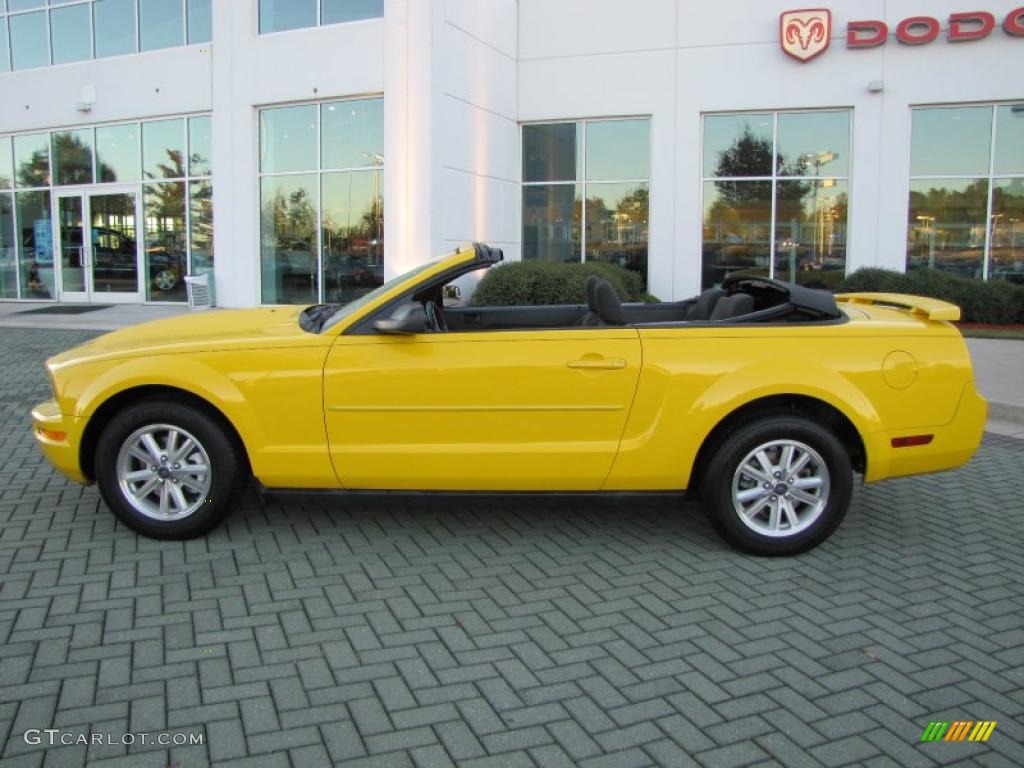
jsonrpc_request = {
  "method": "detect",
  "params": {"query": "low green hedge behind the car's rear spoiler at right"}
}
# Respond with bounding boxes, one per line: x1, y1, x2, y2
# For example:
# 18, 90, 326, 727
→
836, 267, 1024, 325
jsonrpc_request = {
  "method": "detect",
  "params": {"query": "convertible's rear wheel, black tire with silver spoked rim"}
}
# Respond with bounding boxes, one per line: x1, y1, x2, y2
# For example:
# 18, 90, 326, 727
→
700, 414, 853, 556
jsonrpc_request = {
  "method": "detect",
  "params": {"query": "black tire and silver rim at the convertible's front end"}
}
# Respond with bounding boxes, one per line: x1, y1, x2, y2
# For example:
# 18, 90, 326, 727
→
95, 397, 248, 539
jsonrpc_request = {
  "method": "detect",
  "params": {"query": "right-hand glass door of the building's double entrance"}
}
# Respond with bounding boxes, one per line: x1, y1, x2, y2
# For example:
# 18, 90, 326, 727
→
85, 188, 142, 302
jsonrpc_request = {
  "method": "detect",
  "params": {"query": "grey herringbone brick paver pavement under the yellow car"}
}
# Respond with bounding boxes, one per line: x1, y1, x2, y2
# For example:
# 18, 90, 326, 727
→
0, 330, 1024, 768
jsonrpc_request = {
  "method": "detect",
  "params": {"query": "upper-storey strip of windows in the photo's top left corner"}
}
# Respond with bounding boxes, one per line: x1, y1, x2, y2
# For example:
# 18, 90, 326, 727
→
0, 0, 212, 72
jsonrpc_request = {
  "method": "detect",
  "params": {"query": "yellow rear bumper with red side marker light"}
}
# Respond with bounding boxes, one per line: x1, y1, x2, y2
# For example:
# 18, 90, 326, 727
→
864, 382, 988, 482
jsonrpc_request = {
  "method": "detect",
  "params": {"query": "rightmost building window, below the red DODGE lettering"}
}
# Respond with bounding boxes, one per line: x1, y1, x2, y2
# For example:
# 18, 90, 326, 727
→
906, 103, 1024, 283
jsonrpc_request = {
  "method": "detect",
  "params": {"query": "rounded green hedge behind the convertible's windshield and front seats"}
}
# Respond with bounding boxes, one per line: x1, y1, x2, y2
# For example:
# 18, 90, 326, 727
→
473, 260, 657, 306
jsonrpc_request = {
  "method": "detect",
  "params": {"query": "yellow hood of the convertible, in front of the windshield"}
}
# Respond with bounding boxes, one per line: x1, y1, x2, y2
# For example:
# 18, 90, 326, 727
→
48, 306, 324, 369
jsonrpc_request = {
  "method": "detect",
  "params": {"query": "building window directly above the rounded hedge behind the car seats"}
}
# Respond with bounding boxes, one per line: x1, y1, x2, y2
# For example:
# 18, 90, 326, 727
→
522, 119, 650, 286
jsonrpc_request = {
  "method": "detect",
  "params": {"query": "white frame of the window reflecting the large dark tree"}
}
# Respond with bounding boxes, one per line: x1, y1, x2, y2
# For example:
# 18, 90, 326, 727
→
699, 105, 855, 281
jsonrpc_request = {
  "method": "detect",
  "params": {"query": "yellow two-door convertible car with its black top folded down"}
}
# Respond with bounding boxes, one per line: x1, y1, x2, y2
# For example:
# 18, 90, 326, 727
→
32, 244, 986, 555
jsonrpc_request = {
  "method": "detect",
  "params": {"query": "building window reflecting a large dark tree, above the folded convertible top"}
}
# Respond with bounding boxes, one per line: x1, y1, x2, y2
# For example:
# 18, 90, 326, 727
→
701, 110, 851, 288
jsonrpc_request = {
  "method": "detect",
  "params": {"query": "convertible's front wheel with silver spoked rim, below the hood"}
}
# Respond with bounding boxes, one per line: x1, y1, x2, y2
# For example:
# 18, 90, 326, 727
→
95, 399, 246, 539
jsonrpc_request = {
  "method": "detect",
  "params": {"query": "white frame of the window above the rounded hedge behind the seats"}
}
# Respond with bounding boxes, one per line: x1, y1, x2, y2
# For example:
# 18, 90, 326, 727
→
518, 114, 654, 287
